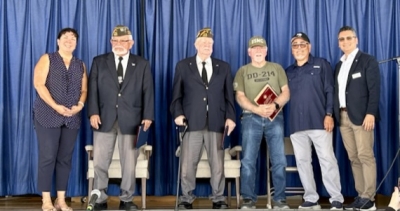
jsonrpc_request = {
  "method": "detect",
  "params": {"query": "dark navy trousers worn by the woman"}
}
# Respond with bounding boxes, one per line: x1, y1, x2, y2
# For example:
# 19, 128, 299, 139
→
35, 121, 79, 192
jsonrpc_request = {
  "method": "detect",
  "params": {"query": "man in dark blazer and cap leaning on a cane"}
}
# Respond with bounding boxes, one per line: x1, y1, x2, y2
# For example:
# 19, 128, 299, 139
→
170, 28, 236, 209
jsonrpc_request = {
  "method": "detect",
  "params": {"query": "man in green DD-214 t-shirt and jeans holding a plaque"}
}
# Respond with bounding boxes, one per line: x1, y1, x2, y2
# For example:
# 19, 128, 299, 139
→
233, 36, 290, 209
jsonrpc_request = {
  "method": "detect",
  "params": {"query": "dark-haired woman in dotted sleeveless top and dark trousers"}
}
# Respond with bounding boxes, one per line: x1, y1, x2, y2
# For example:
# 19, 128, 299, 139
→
33, 28, 87, 211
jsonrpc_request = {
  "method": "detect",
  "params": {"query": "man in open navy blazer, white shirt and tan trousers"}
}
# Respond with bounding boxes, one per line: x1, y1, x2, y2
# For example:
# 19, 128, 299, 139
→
334, 26, 380, 210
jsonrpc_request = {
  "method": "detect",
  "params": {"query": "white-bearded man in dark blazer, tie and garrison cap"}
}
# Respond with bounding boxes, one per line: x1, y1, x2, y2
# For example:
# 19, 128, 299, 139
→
88, 25, 154, 210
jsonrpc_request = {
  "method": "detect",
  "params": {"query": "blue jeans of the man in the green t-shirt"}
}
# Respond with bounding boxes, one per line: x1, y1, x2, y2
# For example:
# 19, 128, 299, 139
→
240, 113, 287, 202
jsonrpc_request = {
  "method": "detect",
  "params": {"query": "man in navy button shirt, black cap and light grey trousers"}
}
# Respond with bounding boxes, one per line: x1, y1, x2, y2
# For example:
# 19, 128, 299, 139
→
286, 32, 343, 210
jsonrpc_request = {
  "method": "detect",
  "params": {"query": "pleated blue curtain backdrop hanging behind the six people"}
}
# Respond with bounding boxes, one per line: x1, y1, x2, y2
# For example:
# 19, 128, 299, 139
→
0, 0, 400, 196
